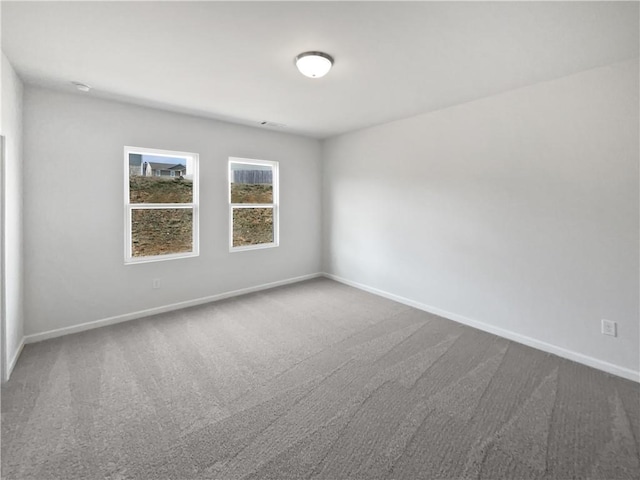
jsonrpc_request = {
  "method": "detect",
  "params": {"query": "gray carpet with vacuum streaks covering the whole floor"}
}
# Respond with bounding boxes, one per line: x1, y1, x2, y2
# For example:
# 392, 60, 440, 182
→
2, 279, 640, 480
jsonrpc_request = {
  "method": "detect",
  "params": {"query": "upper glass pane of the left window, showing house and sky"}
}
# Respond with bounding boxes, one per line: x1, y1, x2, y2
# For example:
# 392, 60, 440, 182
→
129, 153, 193, 203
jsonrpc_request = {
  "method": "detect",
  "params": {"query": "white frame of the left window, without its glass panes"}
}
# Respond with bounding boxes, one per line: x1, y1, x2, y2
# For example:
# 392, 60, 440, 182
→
124, 146, 200, 265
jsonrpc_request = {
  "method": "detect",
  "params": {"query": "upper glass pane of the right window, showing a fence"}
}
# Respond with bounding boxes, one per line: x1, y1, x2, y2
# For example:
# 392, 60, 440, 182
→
230, 162, 273, 203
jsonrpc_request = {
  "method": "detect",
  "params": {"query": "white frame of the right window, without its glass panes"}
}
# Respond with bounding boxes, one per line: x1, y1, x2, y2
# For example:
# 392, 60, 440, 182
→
227, 157, 280, 252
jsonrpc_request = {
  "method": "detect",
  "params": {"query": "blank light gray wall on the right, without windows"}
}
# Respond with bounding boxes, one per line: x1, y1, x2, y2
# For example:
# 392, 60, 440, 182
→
323, 60, 640, 372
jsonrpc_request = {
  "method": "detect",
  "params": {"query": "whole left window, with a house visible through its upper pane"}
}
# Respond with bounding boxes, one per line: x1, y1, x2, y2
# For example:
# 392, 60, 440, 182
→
124, 147, 198, 263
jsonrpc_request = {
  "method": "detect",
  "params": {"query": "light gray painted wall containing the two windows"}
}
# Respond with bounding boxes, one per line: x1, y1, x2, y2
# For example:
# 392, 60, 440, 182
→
24, 86, 321, 335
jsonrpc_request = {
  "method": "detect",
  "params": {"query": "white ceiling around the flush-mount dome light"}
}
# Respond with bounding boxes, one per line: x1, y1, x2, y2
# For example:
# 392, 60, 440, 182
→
2, 1, 639, 138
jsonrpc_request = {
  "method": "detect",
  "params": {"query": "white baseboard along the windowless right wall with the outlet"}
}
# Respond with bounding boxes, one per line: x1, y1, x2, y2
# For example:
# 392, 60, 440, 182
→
324, 273, 640, 382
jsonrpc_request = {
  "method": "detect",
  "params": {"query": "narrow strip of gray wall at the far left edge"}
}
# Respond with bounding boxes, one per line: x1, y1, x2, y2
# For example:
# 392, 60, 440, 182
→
0, 53, 24, 378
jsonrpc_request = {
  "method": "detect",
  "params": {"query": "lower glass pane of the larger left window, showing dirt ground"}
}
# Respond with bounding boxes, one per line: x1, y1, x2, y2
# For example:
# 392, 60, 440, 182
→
131, 208, 193, 257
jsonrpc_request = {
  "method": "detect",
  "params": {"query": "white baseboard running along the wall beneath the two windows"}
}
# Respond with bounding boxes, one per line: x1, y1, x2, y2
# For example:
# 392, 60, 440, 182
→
25, 273, 323, 344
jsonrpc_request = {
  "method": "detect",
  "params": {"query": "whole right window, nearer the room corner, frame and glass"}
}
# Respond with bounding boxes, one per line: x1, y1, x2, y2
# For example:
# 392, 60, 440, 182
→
229, 158, 278, 251
